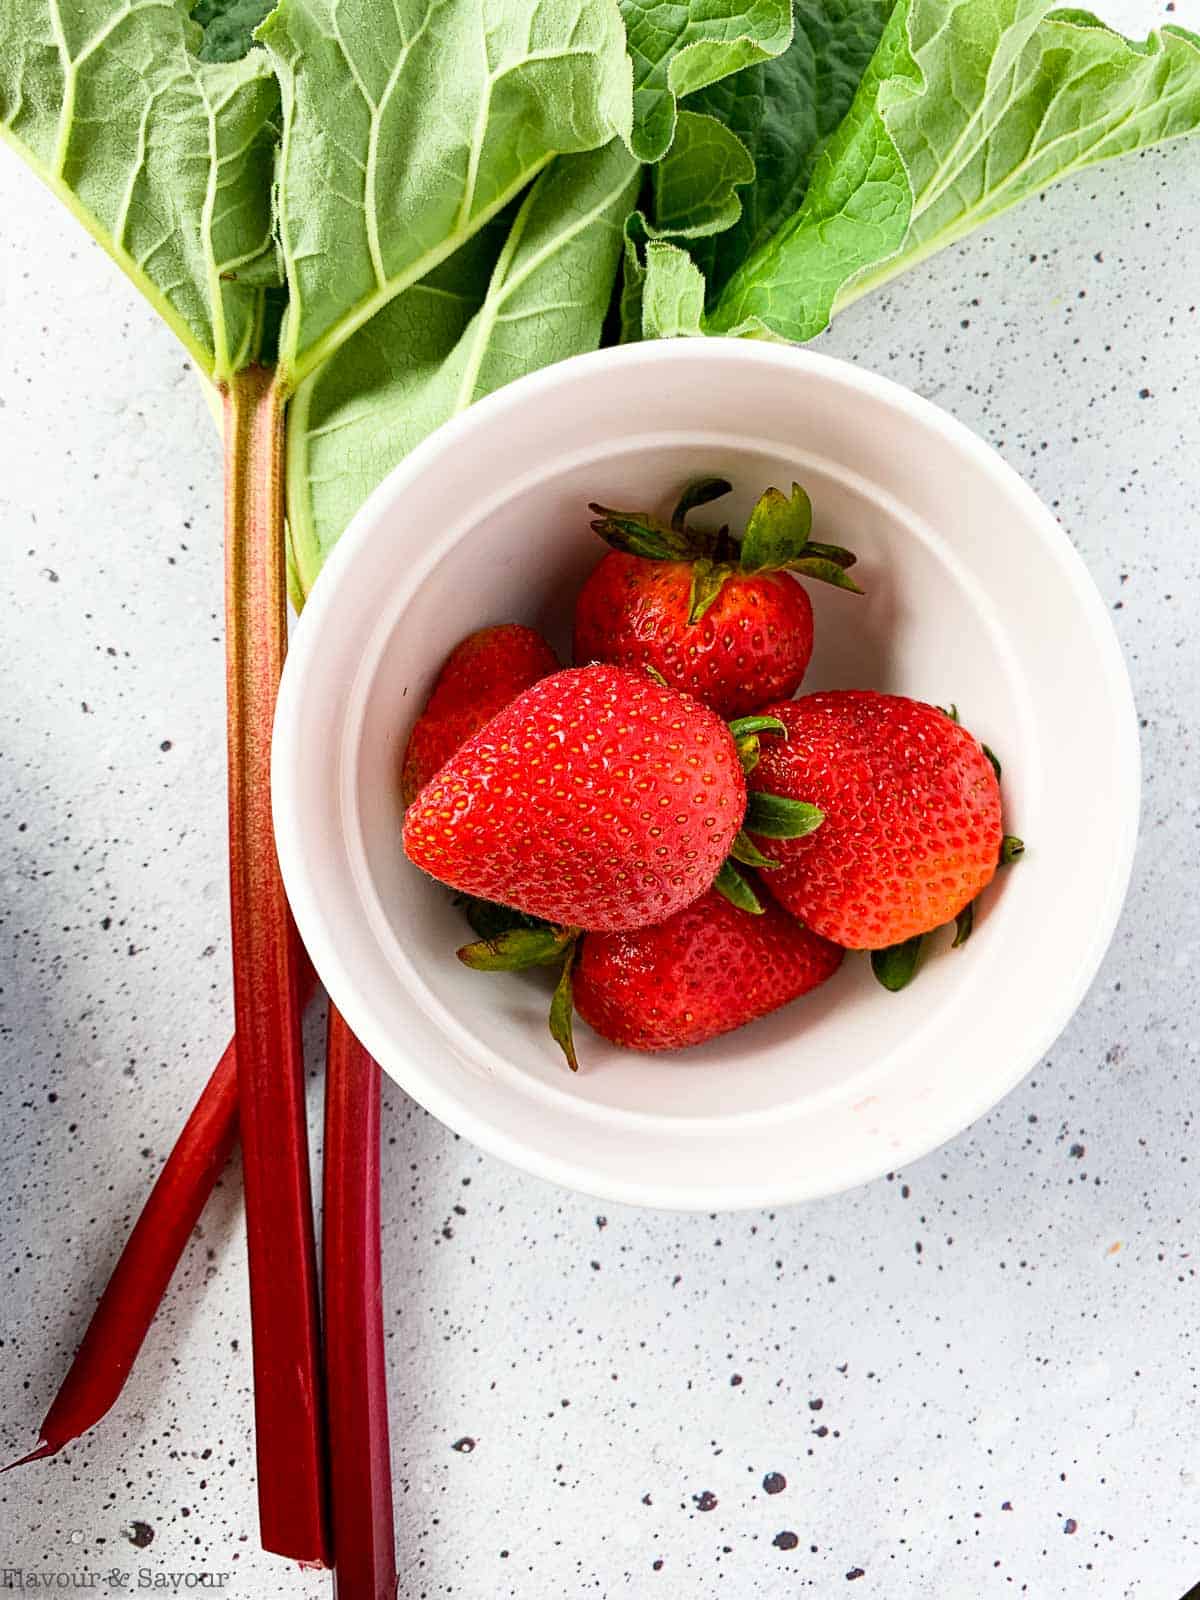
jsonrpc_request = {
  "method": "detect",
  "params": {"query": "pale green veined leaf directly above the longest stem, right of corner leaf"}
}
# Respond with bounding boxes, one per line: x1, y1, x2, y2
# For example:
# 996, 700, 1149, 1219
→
258, 0, 630, 387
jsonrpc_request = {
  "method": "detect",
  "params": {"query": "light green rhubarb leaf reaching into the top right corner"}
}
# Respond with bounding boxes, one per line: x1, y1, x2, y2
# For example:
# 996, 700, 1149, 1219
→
706, 0, 1200, 339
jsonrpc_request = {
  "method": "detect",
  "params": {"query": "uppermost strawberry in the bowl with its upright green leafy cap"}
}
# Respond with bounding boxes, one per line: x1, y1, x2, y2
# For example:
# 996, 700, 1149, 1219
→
574, 478, 859, 717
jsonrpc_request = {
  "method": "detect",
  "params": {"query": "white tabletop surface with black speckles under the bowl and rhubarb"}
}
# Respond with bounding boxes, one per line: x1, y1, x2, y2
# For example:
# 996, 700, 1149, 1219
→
0, 5, 1200, 1600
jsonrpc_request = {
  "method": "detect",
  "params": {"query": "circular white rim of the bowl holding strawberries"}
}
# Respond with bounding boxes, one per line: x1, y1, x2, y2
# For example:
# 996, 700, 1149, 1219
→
272, 338, 1141, 1211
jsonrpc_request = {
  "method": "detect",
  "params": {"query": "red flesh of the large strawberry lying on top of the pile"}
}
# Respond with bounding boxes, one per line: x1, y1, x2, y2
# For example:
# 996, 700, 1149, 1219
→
405, 666, 746, 930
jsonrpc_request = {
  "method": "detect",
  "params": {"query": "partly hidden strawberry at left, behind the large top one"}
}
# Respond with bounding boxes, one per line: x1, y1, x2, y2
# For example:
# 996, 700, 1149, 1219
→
400, 622, 558, 805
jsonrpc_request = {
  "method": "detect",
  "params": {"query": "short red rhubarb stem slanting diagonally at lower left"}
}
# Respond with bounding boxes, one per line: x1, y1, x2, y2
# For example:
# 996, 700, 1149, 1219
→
5, 1040, 237, 1470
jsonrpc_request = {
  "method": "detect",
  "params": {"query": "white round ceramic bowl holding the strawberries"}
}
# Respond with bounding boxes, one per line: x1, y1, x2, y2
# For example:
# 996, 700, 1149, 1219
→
274, 339, 1139, 1211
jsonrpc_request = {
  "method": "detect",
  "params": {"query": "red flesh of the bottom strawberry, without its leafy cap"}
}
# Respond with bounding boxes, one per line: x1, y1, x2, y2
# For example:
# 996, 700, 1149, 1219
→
574, 891, 842, 1050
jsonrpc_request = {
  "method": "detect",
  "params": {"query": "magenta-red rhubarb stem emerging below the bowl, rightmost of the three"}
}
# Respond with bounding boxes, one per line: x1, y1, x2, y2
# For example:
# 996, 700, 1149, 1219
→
322, 1006, 397, 1600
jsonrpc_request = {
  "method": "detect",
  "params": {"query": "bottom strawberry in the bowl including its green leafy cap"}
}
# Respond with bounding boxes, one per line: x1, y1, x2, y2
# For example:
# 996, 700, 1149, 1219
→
458, 890, 843, 1069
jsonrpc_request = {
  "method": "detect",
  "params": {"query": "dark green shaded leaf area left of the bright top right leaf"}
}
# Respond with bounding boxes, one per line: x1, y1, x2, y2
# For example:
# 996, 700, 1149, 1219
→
681, 0, 893, 301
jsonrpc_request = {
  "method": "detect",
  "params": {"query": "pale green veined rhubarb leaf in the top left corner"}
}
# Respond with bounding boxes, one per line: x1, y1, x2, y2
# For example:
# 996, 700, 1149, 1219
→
0, 0, 278, 382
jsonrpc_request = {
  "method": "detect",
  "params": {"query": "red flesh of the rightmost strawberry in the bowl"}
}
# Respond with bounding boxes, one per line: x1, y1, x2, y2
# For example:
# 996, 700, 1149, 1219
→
746, 690, 1002, 958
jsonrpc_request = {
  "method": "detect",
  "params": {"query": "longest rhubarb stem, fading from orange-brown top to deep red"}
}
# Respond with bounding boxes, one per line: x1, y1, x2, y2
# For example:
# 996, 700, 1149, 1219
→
224, 366, 328, 1565
